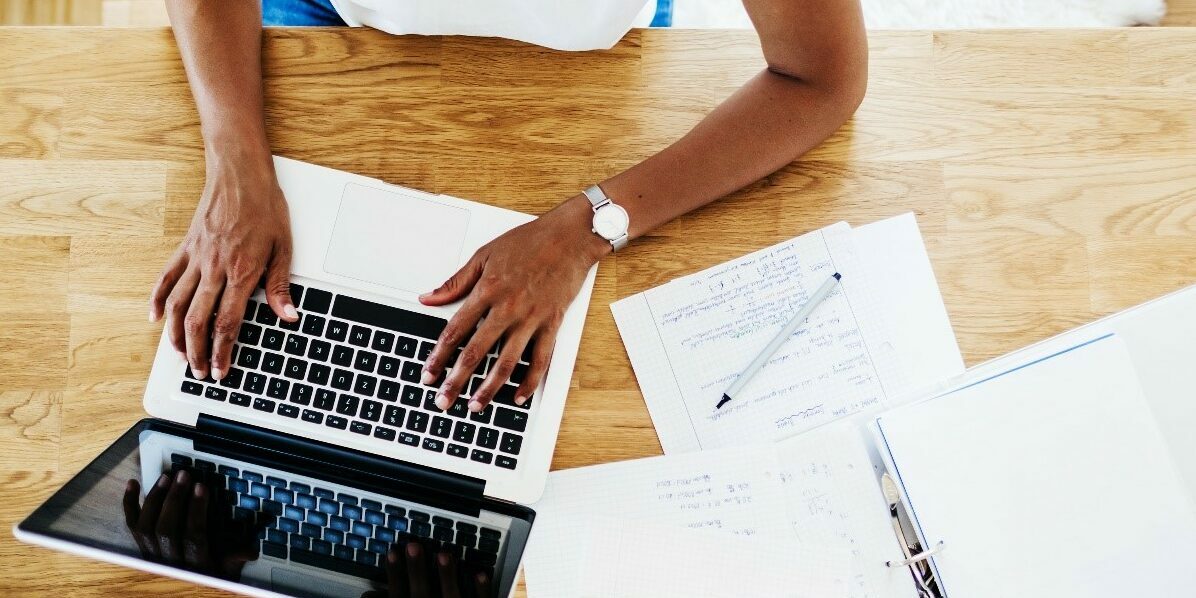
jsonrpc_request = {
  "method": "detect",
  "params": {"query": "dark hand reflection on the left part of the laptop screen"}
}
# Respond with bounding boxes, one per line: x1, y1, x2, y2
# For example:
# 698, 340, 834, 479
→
124, 470, 257, 580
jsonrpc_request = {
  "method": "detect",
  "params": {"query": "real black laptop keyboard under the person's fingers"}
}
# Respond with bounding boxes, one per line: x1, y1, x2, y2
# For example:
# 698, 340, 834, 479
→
181, 285, 533, 469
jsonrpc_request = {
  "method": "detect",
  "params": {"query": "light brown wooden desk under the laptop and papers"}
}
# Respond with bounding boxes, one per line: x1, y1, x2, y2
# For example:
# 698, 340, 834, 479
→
0, 28, 1196, 596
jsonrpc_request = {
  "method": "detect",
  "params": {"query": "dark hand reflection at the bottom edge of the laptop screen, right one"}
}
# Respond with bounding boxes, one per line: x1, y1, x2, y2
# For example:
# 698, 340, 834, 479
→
361, 539, 492, 598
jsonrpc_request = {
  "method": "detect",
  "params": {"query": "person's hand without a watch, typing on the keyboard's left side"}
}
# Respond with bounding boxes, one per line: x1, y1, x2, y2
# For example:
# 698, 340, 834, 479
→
150, 155, 298, 380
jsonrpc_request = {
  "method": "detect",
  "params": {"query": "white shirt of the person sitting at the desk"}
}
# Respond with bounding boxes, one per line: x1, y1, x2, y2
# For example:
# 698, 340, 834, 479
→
331, 0, 655, 50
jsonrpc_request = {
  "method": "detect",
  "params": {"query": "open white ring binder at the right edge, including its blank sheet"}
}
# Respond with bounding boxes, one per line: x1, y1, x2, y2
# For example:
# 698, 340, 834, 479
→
869, 287, 1196, 598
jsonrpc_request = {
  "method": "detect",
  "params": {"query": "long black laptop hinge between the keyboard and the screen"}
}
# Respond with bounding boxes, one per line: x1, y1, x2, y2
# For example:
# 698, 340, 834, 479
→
195, 414, 486, 517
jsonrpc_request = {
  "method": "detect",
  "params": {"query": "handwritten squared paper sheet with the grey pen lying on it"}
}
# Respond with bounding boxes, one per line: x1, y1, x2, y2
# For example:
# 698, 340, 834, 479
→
611, 222, 899, 453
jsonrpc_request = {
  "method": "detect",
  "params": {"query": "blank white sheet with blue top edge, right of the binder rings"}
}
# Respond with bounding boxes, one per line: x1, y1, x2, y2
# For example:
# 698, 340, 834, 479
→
877, 335, 1196, 598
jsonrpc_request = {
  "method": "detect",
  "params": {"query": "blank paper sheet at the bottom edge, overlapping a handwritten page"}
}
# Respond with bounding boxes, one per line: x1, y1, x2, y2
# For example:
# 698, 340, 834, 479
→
576, 518, 843, 598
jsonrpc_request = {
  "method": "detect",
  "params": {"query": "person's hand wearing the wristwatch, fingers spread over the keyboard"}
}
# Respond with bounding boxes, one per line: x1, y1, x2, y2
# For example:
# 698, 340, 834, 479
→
420, 196, 611, 411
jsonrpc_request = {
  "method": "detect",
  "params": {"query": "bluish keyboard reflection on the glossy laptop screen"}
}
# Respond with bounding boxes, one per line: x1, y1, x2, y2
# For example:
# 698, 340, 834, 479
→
170, 452, 502, 581
